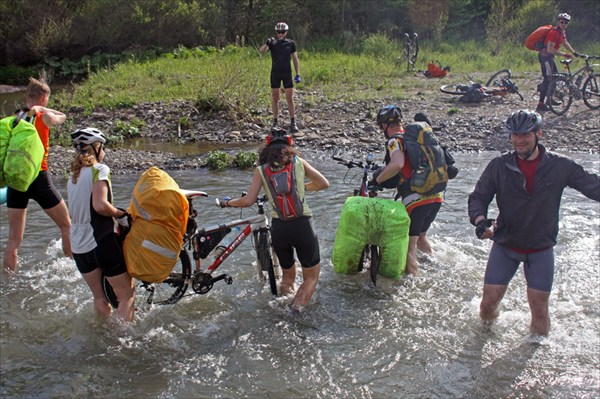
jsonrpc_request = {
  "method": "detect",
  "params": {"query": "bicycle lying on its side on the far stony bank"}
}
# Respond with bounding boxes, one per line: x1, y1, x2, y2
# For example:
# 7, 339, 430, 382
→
440, 69, 523, 102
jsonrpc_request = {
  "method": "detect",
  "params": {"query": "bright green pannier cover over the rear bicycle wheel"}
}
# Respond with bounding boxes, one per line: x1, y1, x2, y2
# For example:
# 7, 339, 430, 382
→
332, 196, 410, 279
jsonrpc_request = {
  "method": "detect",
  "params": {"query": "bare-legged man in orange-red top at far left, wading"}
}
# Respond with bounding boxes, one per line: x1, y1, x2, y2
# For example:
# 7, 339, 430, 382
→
4, 78, 72, 271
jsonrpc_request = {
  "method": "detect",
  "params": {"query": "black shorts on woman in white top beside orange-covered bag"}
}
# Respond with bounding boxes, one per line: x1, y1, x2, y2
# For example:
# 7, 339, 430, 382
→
73, 233, 127, 277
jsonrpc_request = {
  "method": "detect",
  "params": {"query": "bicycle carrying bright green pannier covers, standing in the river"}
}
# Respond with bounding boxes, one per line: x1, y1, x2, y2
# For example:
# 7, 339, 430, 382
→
332, 154, 380, 285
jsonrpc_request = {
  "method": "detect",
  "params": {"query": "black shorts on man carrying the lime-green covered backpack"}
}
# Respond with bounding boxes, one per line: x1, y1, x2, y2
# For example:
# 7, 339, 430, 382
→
6, 170, 62, 209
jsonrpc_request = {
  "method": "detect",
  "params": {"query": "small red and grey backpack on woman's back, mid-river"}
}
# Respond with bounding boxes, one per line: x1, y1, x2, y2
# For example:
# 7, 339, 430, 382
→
261, 157, 304, 220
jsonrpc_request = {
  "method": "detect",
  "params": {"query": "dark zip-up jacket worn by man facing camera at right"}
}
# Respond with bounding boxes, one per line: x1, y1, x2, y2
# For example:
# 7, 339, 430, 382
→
468, 144, 600, 250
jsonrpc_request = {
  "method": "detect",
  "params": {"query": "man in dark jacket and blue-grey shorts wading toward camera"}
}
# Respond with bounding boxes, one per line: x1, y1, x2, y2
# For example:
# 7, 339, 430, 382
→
468, 110, 600, 335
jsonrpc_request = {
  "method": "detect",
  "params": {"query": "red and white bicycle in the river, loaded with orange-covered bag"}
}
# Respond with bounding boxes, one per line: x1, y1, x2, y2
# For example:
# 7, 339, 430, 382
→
103, 191, 281, 308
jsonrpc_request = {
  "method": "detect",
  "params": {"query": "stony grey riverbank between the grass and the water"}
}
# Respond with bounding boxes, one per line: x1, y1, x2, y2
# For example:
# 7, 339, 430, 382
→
45, 74, 600, 175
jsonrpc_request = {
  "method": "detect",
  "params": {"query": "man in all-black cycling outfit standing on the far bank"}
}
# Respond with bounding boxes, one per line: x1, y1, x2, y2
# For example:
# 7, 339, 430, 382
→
259, 22, 301, 132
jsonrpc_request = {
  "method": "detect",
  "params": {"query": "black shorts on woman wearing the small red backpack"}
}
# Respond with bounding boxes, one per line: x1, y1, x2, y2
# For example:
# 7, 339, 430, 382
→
271, 216, 321, 269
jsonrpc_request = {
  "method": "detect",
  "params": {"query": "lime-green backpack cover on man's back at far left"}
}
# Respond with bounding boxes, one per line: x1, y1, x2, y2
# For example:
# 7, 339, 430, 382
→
0, 116, 44, 192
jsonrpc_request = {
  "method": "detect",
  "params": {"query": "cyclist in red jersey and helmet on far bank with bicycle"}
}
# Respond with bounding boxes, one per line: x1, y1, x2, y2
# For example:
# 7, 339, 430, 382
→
536, 13, 578, 112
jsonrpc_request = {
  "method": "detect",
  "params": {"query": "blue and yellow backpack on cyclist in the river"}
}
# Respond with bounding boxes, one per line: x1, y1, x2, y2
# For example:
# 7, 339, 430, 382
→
397, 122, 448, 195
